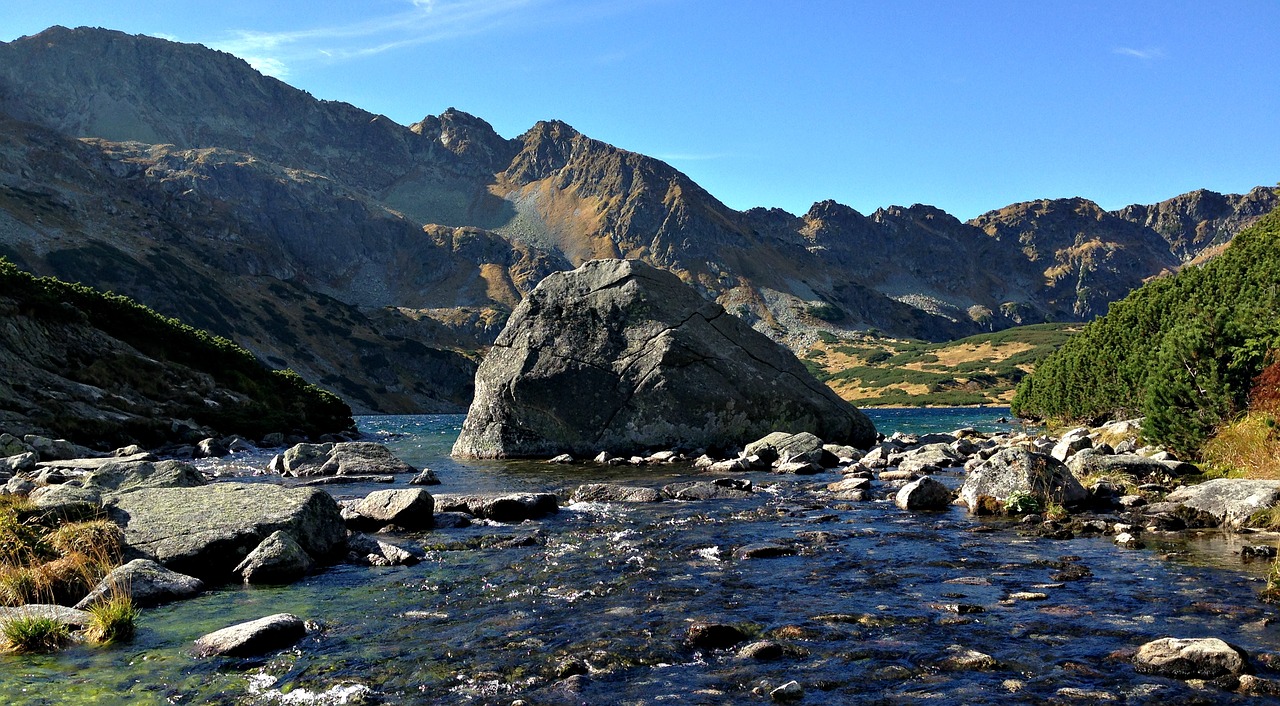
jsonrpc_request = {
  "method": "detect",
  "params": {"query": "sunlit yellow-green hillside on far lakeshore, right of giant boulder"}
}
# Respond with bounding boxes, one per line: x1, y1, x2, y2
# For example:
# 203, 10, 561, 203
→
804, 324, 1080, 407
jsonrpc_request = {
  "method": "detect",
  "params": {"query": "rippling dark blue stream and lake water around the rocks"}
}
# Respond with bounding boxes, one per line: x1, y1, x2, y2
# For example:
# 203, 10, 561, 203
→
0, 408, 1280, 705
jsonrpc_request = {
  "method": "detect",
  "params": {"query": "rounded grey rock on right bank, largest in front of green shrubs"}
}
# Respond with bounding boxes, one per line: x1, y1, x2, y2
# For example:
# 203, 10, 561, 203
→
960, 448, 1089, 512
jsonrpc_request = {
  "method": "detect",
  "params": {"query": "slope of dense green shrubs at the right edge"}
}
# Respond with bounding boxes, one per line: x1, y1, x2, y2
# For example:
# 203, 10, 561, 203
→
1014, 208, 1280, 455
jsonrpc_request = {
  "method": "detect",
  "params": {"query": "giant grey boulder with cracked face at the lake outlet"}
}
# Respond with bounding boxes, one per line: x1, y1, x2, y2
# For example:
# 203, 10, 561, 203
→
453, 260, 876, 458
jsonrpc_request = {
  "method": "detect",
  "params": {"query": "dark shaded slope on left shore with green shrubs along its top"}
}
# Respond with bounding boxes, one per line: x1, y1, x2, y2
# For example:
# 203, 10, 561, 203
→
0, 260, 355, 448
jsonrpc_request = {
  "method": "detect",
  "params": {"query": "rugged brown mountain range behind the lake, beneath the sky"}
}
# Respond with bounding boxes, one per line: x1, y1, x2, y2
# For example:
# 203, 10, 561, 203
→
0, 27, 1280, 413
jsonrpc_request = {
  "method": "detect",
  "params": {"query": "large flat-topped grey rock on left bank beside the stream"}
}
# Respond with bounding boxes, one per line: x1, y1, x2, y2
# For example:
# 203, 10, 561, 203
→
108, 483, 347, 581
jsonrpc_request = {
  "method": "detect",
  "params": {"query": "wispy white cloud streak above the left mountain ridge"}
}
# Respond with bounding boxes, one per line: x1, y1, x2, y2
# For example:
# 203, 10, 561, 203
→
205, 0, 548, 77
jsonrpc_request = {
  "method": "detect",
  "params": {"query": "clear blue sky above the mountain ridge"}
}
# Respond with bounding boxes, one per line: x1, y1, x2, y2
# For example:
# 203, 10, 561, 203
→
0, 0, 1280, 219
